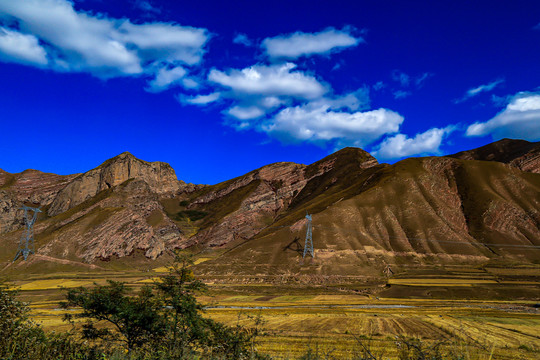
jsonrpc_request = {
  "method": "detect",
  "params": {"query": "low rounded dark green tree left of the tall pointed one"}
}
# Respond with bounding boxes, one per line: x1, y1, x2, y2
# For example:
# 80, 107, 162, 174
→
61, 281, 164, 351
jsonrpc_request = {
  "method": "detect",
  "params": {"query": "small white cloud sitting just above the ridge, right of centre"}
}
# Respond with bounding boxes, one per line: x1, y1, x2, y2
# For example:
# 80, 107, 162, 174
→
373, 126, 454, 159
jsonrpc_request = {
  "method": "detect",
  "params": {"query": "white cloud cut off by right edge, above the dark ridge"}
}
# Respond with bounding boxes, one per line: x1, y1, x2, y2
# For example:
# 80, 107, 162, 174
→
466, 92, 540, 141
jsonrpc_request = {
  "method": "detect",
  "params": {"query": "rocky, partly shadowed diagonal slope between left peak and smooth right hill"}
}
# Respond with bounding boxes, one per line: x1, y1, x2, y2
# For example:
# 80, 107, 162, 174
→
165, 148, 378, 247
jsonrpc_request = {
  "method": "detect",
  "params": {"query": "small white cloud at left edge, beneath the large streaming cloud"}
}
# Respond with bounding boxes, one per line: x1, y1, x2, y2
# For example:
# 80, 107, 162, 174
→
0, 27, 48, 66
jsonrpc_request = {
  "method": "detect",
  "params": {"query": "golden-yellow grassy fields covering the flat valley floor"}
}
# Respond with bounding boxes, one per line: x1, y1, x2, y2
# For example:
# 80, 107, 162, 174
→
5, 267, 540, 360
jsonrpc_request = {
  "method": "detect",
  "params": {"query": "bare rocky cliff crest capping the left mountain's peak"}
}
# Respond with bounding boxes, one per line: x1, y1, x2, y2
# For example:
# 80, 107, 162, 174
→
48, 152, 184, 216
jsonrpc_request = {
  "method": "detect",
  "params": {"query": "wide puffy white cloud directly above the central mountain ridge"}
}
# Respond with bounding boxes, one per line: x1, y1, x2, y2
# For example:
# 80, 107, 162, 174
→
262, 100, 403, 146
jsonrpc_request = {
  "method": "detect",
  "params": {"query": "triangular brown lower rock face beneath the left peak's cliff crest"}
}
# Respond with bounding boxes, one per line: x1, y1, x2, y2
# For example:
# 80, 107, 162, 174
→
36, 179, 182, 263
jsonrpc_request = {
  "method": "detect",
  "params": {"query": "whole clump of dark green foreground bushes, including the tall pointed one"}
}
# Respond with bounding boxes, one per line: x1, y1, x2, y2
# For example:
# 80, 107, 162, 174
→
62, 254, 266, 359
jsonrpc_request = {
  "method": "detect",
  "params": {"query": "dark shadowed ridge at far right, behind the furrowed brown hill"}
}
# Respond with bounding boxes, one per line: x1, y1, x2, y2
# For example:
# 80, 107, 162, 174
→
449, 139, 540, 173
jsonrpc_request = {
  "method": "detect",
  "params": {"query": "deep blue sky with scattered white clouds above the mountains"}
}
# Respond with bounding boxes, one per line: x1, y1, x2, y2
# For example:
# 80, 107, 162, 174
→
0, 0, 540, 184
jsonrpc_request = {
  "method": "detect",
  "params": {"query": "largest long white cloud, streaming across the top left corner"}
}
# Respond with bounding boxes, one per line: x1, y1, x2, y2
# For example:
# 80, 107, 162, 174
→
0, 0, 209, 81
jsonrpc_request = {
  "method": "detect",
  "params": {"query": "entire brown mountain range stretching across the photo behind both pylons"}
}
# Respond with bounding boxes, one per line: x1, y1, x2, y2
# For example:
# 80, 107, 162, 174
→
0, 140, 540, 277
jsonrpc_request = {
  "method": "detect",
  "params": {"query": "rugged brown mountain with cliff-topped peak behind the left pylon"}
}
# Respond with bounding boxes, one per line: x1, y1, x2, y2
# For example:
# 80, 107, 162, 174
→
0, 153, 192, 270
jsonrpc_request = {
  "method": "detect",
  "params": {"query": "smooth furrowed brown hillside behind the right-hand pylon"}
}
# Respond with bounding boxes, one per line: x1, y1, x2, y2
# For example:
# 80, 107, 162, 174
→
199, 157, 540, 277
